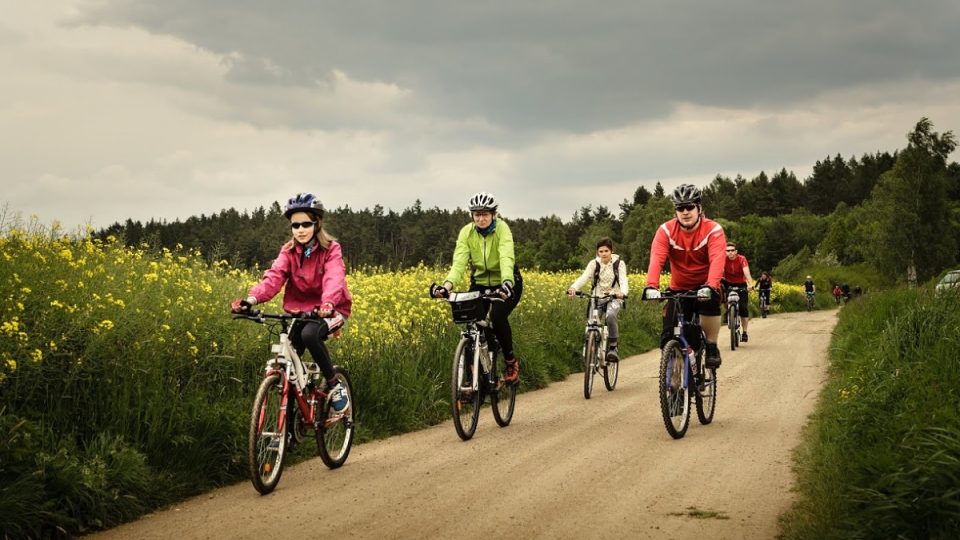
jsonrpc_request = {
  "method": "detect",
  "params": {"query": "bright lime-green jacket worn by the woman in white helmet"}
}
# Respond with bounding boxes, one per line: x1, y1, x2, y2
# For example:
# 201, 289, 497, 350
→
444, 218, 515, 287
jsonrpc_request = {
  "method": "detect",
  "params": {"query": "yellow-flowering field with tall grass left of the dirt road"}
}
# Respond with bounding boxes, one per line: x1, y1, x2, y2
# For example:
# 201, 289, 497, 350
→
0, 224, 816, 536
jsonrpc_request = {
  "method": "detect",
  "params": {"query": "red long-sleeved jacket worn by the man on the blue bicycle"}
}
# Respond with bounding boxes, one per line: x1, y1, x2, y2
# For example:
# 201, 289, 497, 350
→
647, 217, 727, 291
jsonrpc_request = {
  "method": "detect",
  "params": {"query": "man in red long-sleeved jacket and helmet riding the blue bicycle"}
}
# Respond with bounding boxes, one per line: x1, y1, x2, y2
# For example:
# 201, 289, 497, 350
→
643, 184, 727, 368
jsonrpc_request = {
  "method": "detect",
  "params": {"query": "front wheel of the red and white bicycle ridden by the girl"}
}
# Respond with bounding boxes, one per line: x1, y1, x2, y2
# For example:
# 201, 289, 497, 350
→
247, 373, 287, 495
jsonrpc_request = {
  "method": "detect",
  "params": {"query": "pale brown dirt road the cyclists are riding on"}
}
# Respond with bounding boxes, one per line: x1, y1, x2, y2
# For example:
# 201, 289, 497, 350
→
98, 311, 836, 540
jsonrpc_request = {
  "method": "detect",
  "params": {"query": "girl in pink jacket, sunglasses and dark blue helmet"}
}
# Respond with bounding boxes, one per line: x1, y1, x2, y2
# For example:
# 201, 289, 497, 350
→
231, 193, 353, 412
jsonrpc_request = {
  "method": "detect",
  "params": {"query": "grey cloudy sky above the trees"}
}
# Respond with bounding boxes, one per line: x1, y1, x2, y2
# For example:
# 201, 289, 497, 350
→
0, 0, 960, 227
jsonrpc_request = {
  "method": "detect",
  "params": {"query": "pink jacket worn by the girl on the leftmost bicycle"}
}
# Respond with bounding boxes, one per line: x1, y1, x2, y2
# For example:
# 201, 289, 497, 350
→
249, 242, 353, 317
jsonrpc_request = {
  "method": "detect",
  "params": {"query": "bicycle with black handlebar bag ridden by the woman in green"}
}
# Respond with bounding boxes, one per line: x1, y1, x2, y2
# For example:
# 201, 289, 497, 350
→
447, 291, 517, 441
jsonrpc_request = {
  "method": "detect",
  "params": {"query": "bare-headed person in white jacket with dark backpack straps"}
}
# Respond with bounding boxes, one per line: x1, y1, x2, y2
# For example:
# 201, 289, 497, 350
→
567, 238, 630, 362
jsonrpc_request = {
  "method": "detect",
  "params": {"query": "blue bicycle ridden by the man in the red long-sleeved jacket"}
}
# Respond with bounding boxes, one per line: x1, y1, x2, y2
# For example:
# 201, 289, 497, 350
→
654, 291, 717, 439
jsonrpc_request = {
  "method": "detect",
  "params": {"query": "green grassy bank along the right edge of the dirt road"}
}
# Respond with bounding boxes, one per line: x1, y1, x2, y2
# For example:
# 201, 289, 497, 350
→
782, 289, 960, 538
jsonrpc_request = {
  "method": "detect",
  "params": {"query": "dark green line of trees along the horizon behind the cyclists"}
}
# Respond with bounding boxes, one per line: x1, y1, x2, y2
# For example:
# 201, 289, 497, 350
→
96, 118, 960, 280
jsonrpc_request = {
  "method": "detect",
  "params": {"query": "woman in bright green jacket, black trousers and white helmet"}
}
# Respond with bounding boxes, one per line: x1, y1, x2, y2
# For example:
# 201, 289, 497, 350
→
430, 192, 523, 383
